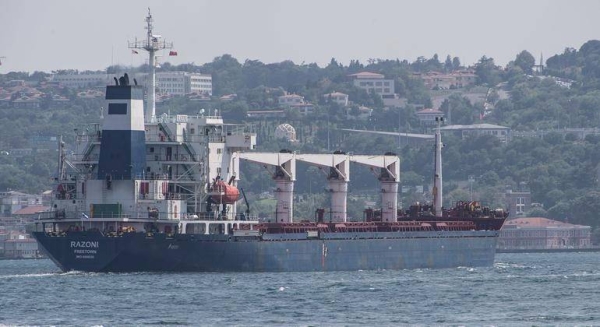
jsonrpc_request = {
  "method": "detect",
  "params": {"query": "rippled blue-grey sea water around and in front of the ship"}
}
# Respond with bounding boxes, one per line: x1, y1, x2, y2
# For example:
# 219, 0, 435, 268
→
0, 252, 600, 326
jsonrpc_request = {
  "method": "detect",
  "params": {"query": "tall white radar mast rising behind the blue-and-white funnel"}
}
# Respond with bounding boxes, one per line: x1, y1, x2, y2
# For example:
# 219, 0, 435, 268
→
129, 8, 173, 122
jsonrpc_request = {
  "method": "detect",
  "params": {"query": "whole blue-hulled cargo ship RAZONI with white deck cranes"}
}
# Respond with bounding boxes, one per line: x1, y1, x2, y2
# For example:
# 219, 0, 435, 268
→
32, 11, 507, 272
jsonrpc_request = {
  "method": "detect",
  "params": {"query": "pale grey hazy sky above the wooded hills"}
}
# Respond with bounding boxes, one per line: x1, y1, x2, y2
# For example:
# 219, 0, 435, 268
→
0, 0, 600, 73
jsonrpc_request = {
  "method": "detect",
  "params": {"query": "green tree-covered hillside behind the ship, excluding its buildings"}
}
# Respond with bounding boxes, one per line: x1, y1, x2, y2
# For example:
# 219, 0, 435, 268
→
0, 40, 600, 238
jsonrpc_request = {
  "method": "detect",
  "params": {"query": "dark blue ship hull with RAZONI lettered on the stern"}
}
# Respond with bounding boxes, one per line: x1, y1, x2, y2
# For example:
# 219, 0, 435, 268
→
34, 231, 498, 272
